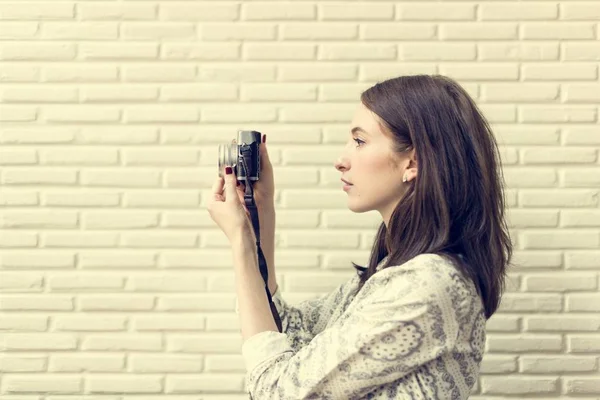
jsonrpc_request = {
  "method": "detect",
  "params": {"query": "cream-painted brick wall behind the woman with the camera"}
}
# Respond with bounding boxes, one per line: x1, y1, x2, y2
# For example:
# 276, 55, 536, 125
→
0, 0, 600, 400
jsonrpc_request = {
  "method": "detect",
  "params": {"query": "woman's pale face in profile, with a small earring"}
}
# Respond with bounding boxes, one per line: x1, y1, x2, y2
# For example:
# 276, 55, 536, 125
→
335, 103, 416, 226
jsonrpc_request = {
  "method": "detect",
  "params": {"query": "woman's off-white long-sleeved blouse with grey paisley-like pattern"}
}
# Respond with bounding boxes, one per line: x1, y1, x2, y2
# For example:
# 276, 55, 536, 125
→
237, 254, 486, 400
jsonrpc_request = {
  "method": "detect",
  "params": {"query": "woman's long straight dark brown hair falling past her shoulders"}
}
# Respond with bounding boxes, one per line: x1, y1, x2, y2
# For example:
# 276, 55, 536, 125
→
352, 75, 512, 318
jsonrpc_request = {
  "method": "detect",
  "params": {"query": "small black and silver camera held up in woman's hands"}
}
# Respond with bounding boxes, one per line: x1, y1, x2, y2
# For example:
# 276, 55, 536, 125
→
219, 131, 262, 183
